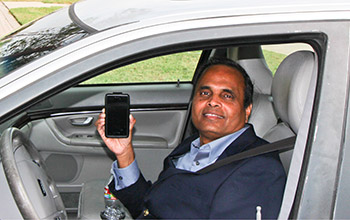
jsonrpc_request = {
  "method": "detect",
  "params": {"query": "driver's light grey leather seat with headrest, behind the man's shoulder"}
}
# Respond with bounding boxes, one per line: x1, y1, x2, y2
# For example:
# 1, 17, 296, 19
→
263, 51, 317, 172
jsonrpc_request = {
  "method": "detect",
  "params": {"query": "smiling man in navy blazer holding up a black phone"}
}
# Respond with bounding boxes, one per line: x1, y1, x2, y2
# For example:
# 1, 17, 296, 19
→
96, 56, 286, 219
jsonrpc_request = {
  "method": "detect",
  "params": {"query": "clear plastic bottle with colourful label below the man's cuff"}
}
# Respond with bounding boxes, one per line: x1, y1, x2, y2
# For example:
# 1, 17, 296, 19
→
100, 185, 125, 220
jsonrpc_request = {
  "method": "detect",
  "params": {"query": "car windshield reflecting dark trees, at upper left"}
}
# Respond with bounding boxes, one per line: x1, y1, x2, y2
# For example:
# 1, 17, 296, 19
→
0, 7, 88, 78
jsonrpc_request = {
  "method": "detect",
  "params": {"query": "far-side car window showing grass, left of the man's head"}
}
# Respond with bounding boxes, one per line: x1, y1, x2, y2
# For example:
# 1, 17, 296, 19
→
82, 51, 201, 85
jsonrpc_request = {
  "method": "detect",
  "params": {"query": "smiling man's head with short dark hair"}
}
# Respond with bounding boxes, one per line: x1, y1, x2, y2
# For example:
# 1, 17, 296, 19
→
192, 65, 252, 144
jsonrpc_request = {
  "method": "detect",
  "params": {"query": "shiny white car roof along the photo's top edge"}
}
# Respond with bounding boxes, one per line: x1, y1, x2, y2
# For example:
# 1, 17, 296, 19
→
70, 0, 350, 32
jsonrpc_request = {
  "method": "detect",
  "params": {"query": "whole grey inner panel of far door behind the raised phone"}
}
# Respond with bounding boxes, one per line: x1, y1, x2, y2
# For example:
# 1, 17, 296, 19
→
23, 83, 192, 209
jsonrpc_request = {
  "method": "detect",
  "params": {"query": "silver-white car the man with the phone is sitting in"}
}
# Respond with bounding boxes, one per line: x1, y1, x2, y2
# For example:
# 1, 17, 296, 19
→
0, 0, 350, 219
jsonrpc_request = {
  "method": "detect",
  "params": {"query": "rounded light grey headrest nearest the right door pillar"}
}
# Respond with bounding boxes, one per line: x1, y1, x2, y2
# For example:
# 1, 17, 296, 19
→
272, 51, 317, 133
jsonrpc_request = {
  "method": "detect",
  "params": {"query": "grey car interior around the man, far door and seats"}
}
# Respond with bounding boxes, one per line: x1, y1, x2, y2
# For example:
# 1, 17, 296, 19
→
0, 40, 318, 219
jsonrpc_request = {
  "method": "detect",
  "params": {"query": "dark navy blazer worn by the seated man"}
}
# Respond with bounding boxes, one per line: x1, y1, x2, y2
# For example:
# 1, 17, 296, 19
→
110, 125, 286, 219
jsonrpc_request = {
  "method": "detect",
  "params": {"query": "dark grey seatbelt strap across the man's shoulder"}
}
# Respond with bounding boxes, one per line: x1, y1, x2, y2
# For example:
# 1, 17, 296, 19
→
196, 136, 296, 174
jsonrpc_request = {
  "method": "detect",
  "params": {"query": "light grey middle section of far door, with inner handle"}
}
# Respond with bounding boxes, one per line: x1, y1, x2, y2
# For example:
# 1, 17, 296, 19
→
30, 110, 187, 154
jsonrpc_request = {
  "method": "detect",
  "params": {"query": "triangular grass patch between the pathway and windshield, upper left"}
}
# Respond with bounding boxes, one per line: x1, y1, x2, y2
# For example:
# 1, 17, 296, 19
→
10, 6, 62, 25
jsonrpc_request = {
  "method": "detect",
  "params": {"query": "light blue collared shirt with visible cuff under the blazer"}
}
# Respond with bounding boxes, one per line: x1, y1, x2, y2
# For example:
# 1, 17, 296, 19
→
111, 126, 248, 190
